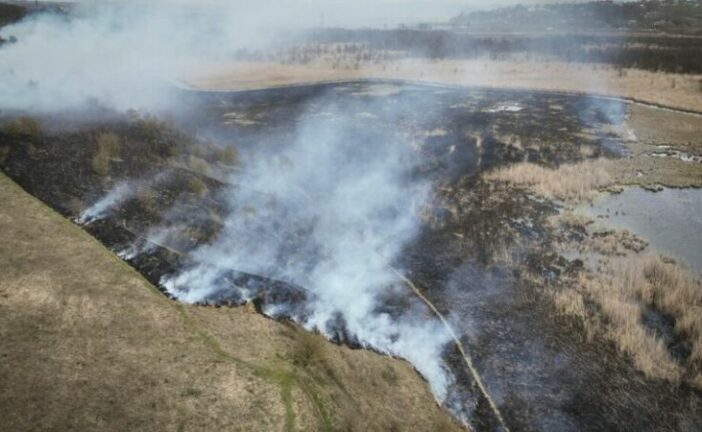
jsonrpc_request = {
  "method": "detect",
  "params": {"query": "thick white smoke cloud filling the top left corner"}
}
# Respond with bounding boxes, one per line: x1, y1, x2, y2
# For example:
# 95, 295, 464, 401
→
0, 1, 316, 111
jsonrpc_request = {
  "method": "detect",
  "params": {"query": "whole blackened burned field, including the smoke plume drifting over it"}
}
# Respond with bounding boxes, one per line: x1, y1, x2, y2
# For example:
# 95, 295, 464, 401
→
0, 82, 702, 431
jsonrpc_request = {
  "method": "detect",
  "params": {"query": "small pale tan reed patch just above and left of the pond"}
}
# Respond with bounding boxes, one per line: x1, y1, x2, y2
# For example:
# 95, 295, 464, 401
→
484, 159, 614, 201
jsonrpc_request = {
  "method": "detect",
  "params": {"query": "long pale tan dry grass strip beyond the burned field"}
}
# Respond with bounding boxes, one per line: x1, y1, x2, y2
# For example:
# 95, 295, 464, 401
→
183, 59, 702, 111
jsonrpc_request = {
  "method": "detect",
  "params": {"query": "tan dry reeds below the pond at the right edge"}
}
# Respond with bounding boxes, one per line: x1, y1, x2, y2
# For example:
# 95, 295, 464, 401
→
553, 255, 702, 388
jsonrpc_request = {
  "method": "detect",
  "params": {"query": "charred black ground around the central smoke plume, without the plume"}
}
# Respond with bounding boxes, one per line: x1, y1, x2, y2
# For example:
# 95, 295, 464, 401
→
0, 83, 702, 430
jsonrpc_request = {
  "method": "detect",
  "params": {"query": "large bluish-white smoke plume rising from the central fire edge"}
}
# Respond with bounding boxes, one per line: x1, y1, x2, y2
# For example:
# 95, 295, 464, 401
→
164, 94, 450, 400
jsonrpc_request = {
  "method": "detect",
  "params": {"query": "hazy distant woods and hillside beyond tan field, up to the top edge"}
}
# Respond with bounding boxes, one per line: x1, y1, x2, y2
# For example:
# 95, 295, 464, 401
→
309, 0, 702, 74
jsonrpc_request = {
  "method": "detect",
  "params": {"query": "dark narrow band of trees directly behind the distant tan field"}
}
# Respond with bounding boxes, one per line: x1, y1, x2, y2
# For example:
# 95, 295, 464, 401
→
308, 29, 702, 73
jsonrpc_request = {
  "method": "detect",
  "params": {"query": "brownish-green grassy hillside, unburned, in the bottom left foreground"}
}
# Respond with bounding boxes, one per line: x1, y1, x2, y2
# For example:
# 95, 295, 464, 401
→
0, 174, 461, 431
